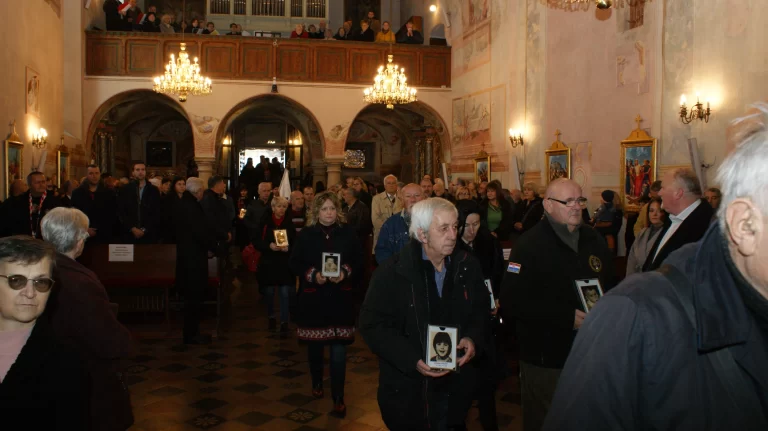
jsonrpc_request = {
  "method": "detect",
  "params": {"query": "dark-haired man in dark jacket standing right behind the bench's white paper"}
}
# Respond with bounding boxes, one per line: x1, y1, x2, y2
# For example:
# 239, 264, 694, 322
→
117, 161, 161, 244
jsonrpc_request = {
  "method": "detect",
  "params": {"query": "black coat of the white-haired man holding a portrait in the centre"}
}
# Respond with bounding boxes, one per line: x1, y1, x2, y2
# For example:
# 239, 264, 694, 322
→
360, 240, 490, 430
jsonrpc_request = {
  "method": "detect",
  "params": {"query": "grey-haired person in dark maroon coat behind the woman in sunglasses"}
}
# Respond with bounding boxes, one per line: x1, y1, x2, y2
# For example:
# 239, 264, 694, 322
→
41, 207, 133, 430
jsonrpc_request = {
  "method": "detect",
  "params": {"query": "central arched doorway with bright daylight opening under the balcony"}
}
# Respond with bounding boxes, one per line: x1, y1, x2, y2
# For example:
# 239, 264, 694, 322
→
216, 94, 325, 193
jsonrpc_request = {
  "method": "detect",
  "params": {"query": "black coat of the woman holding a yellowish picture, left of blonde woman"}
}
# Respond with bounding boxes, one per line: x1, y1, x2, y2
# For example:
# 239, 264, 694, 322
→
253, 211, 296, 290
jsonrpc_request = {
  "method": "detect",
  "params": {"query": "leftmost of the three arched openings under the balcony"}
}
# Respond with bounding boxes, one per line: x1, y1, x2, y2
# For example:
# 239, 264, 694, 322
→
86, 90, 190, 178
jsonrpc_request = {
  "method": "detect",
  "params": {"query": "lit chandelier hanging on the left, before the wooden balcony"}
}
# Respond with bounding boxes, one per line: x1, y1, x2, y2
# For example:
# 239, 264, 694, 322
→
152, 42, 211, 102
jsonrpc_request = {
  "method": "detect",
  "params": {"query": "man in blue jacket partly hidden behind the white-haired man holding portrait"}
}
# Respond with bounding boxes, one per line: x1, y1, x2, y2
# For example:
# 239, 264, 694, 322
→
374, 183, 424, 265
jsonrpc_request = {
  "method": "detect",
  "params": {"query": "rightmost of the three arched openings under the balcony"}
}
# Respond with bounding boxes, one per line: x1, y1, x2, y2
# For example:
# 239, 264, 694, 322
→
342, 102, 450, 187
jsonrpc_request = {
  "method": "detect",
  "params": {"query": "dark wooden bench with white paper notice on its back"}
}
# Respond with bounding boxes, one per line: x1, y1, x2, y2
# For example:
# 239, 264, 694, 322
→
79, 244, 221, 332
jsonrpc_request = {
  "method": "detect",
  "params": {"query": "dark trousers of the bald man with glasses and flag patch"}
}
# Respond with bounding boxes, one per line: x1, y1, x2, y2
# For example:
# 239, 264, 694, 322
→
520, 361, 563, 431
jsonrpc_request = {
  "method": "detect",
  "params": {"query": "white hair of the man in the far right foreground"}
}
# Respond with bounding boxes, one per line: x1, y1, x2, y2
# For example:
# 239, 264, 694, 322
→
717, 102, 768, 231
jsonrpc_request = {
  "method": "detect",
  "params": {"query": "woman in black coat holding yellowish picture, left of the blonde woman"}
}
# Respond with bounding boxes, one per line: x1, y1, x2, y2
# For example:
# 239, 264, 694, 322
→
252, 196, 296, 334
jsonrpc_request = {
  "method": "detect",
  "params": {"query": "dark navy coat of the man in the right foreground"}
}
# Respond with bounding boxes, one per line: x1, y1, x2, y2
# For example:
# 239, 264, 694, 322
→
543, 225, 768, 431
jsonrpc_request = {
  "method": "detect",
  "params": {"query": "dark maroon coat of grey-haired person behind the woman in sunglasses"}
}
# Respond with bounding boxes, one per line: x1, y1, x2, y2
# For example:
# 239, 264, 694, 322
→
46, 254, 133, 431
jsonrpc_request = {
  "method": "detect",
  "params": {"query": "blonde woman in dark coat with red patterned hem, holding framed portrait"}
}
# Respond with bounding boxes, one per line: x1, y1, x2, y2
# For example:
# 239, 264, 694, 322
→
291, 192, 363, 417
